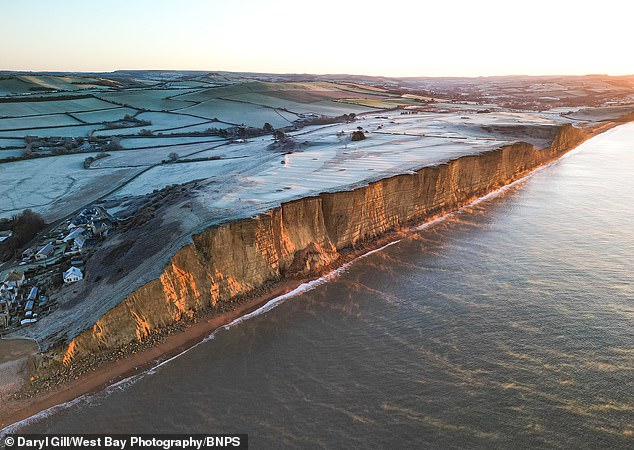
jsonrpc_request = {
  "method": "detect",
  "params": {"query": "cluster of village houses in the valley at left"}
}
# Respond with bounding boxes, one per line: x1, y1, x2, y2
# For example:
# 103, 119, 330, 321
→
0, 206, 116, 334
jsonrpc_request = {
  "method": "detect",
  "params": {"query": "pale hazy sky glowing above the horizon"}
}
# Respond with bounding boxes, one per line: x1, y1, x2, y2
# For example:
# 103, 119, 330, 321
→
0, 0, 634, 76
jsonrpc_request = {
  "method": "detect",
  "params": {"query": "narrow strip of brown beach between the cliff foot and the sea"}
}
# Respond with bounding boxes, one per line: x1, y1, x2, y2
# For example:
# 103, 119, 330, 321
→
0, 121, 627, 431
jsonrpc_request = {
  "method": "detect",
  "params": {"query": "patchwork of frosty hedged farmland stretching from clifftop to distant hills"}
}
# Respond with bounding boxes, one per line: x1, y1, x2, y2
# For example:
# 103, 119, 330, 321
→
0, 71, 631, 225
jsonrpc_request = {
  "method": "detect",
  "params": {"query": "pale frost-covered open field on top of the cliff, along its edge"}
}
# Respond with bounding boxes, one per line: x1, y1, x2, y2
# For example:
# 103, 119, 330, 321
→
98, 112, 552, 204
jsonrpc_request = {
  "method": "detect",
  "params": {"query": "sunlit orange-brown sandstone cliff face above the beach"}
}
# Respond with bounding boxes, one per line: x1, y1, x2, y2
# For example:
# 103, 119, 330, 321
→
55, 125, 587, 364
